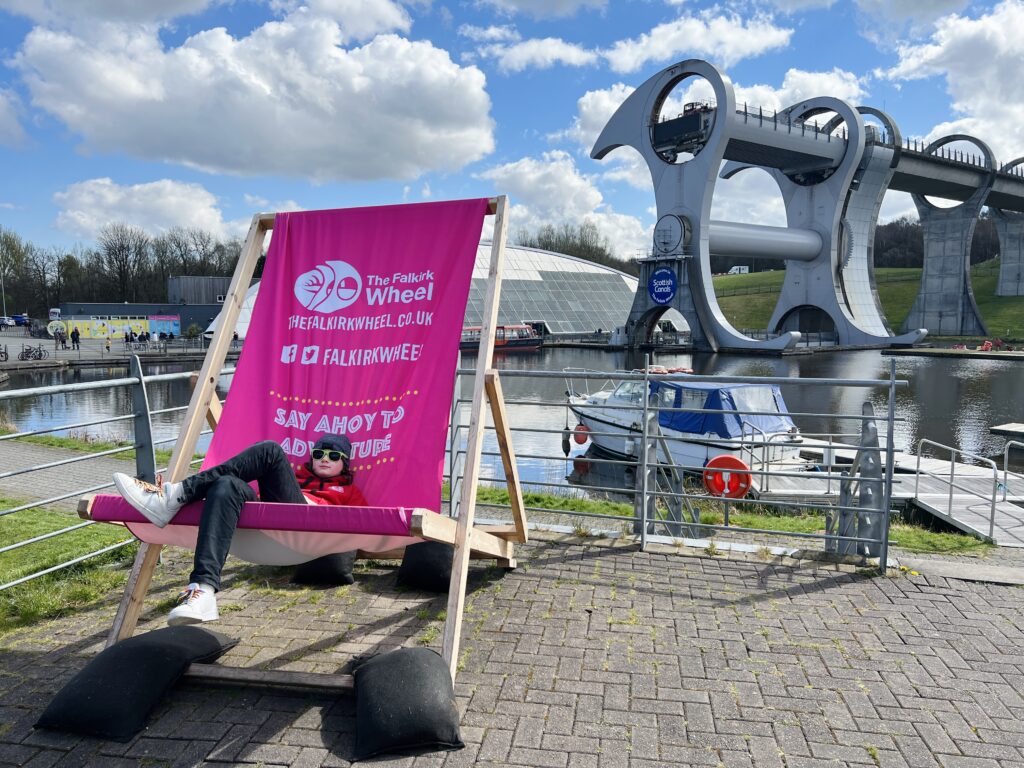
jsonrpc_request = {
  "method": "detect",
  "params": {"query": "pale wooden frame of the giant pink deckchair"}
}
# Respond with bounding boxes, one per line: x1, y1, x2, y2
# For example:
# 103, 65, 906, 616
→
91, 196, 527, 690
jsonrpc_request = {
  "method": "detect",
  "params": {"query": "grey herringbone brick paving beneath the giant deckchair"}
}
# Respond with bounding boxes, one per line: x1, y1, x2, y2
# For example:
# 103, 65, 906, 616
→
0, 536, 1024, 768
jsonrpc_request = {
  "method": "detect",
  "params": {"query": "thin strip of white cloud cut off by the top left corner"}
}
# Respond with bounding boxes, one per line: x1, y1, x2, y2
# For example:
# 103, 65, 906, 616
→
0, 0, 213, 25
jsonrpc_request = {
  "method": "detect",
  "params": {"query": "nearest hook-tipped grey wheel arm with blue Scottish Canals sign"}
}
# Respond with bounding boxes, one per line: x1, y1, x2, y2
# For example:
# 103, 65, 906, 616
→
591, 59, 799, 351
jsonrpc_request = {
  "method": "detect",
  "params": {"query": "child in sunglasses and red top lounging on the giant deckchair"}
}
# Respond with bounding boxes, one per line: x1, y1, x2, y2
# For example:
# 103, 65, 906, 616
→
114, 434, 367, 626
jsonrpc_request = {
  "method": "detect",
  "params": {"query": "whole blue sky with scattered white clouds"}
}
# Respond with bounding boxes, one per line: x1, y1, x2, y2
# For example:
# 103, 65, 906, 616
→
0, 0, 1024, 257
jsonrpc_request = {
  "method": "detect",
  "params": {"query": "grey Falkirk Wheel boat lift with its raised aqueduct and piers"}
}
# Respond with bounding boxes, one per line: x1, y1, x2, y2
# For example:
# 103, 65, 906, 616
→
591, 59, 1024, 351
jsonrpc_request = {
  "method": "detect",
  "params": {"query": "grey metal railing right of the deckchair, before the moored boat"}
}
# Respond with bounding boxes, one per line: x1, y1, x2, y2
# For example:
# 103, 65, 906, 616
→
449, 365, 906, 568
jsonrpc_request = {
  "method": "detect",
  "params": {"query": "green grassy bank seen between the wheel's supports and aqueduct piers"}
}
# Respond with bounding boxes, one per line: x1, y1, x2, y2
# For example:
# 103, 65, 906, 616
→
715, 259, 1024, 340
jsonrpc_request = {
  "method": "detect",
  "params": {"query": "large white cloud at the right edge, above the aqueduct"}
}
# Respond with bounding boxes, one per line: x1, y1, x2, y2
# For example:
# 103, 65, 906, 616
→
882, 0, 1024, 159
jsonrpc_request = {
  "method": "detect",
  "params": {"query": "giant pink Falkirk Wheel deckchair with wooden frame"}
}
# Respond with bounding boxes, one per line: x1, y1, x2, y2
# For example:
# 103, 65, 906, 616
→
80, 197, 526, 688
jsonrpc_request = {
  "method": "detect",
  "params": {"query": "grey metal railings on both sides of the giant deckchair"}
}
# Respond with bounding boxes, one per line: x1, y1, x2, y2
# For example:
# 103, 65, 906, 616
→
0, 357, 901, 590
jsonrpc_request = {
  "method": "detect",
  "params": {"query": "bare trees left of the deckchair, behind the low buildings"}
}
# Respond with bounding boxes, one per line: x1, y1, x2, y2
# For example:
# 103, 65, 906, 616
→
0, 224, 242, 317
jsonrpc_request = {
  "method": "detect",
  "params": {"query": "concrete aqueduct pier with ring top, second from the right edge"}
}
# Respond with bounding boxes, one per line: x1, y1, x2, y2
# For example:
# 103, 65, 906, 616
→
903, 133, 996, 336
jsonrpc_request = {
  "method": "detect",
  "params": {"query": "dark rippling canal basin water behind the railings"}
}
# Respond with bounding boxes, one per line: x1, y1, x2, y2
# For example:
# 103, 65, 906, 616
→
0, 348, 1024, 493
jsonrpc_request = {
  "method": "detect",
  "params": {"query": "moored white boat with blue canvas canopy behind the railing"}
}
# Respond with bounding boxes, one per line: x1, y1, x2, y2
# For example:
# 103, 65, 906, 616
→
566, 369, 803, 472
